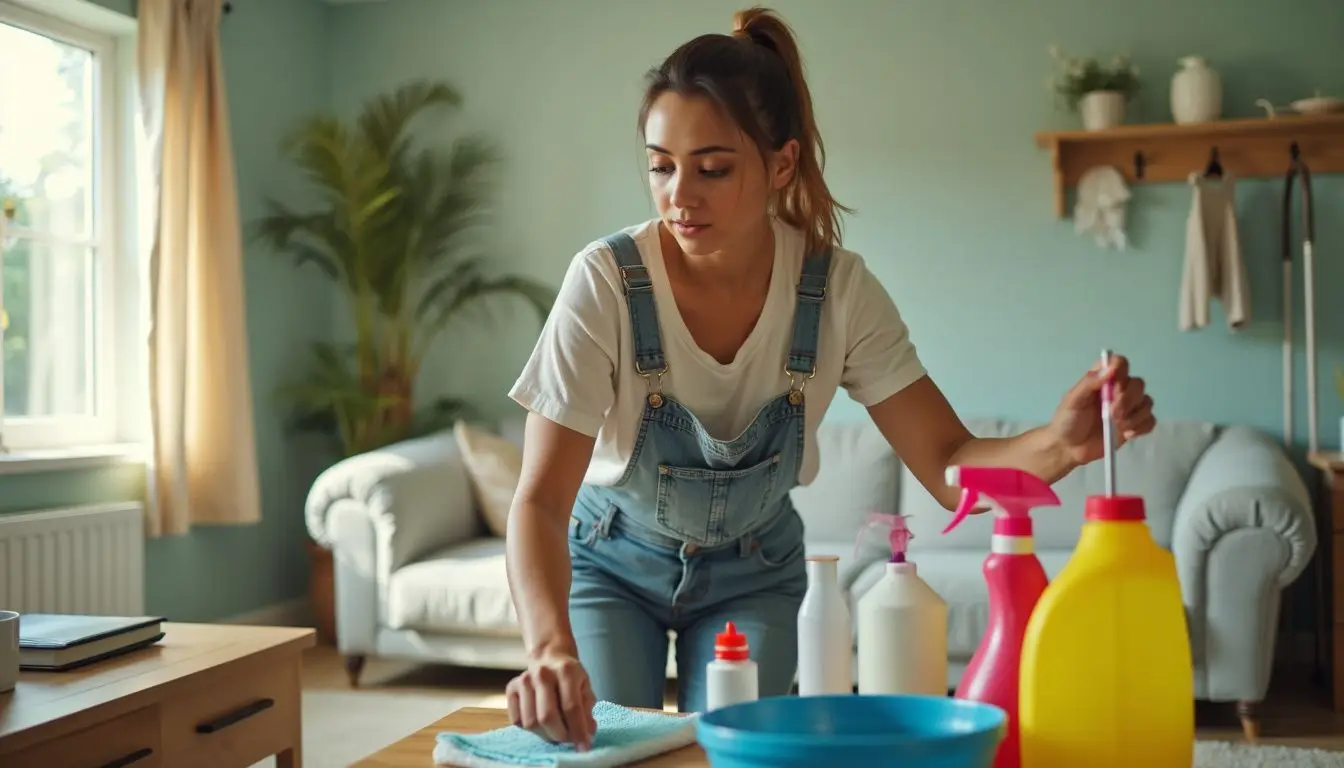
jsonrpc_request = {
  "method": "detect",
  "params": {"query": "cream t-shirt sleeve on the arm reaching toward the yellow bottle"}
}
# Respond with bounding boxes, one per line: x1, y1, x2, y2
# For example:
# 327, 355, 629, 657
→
840, 260, 926, 406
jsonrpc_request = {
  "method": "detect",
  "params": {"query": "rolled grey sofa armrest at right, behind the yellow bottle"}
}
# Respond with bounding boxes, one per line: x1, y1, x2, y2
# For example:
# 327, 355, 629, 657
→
1172, 426, 1316, 701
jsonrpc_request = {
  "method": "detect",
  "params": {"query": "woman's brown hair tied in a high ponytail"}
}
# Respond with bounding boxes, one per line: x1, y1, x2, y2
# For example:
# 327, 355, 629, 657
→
640, 7, 852, 256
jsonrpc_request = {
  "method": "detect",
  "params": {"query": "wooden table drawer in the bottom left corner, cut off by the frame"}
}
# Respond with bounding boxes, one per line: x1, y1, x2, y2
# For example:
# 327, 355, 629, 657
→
0, 706, 161, 768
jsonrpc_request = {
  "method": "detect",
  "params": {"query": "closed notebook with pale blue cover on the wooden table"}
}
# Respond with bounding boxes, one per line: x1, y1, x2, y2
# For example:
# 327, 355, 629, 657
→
19, 613, 165, 671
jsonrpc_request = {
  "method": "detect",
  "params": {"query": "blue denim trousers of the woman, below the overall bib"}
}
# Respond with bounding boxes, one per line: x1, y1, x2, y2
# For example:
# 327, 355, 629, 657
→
570, 495, 808, 712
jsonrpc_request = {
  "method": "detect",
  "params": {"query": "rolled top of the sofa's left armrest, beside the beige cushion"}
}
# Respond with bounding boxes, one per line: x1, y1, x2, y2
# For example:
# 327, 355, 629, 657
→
305, 432, 484, 574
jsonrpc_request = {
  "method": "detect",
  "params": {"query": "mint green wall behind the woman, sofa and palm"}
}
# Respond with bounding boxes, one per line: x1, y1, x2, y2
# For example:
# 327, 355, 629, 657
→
13, 0, 1344, 619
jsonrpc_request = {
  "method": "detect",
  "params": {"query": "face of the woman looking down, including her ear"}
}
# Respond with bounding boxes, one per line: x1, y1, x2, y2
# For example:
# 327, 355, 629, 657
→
644, 93, 798, 256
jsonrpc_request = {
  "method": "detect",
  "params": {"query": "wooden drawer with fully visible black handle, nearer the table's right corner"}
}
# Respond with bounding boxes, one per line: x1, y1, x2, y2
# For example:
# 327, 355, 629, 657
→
163, 662, 300, 768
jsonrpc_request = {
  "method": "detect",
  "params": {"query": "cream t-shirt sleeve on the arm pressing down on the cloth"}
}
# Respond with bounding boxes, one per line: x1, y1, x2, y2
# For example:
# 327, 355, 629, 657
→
509, 247, 621, 437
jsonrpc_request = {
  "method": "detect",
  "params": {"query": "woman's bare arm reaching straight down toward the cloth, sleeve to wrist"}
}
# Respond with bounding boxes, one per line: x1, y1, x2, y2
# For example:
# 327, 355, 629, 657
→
504, 413, 594, 659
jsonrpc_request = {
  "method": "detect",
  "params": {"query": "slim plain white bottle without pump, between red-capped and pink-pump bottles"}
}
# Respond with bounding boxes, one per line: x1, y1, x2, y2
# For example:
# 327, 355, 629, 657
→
798, 554, 853, 695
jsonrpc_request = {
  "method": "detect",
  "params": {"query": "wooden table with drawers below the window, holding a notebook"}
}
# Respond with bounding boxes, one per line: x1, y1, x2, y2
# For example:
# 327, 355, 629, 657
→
0, 623, 316, 768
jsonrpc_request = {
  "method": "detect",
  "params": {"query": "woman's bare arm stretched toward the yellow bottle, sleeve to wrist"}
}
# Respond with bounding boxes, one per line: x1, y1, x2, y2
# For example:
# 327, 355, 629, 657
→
868, 375, 1077, 511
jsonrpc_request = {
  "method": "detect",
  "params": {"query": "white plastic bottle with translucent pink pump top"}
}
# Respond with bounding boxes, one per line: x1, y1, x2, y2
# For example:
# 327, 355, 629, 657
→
855, 515, 949, 695
